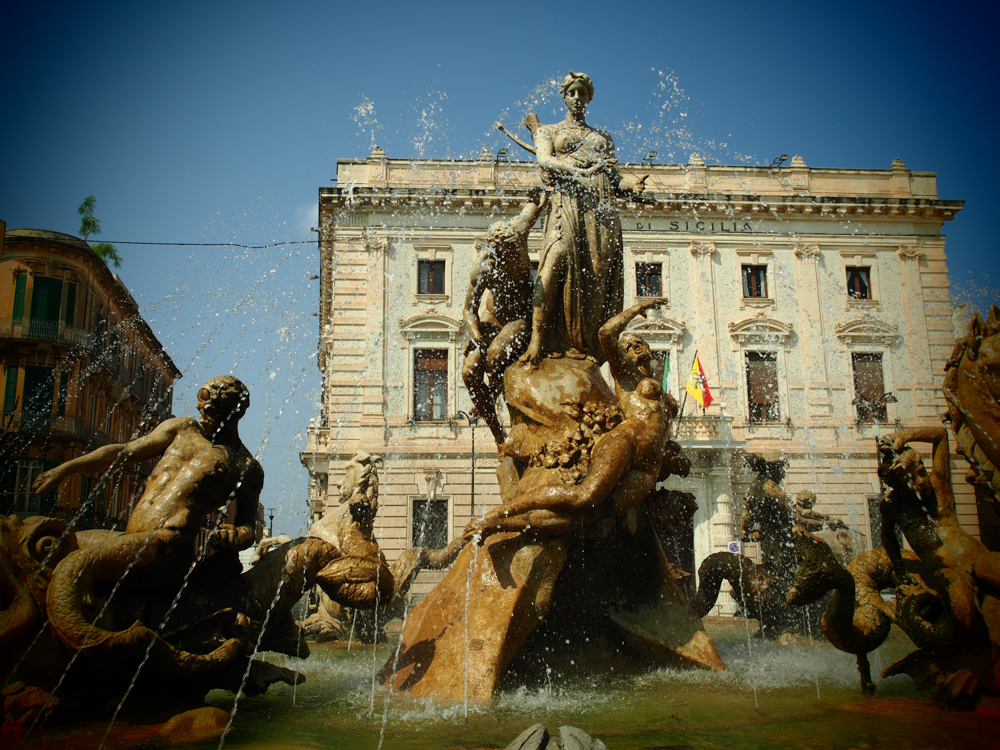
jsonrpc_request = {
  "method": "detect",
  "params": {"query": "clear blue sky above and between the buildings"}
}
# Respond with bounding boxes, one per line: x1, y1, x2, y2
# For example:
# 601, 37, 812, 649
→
0, 0, 1000, 533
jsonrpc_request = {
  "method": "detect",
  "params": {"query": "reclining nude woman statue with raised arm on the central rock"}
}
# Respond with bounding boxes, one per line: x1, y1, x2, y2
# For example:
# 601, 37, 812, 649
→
465, 300, 690, 543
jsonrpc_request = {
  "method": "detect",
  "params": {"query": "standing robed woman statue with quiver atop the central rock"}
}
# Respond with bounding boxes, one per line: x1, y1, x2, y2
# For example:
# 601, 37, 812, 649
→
521, 71, 646, 365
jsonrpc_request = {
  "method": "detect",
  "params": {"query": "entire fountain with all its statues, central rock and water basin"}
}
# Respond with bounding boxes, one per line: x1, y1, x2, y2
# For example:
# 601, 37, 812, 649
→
0, 73, 1000, 750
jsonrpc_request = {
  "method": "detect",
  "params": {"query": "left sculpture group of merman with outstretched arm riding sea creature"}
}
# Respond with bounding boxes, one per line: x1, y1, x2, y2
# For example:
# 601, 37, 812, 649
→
0, 376, 393, 726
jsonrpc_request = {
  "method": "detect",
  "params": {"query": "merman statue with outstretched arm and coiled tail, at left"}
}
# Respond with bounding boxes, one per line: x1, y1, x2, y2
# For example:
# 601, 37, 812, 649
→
33, 375, 264, 670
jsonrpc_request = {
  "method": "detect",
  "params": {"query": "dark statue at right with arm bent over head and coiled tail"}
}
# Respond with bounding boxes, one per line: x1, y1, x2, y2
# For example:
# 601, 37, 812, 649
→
789, 427, 1000, 707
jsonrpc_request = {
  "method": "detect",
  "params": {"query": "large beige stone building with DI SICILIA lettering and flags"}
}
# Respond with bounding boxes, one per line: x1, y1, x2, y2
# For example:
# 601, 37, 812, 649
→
302, 148, 978, 604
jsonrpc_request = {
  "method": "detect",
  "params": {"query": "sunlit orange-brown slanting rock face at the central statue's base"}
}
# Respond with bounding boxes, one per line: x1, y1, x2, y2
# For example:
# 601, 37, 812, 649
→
379, 534, 566, 702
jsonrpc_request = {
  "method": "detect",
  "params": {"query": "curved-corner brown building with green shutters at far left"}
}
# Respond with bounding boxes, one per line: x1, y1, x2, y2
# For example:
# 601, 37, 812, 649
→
0, 229, 181, 529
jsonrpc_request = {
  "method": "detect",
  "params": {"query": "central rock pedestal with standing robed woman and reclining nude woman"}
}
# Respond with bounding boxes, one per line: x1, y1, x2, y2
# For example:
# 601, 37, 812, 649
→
380, 73, 725, 701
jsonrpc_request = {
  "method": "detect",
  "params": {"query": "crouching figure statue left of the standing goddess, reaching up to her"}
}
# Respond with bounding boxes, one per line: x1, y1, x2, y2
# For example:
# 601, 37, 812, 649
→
462, 190, 547, 445
